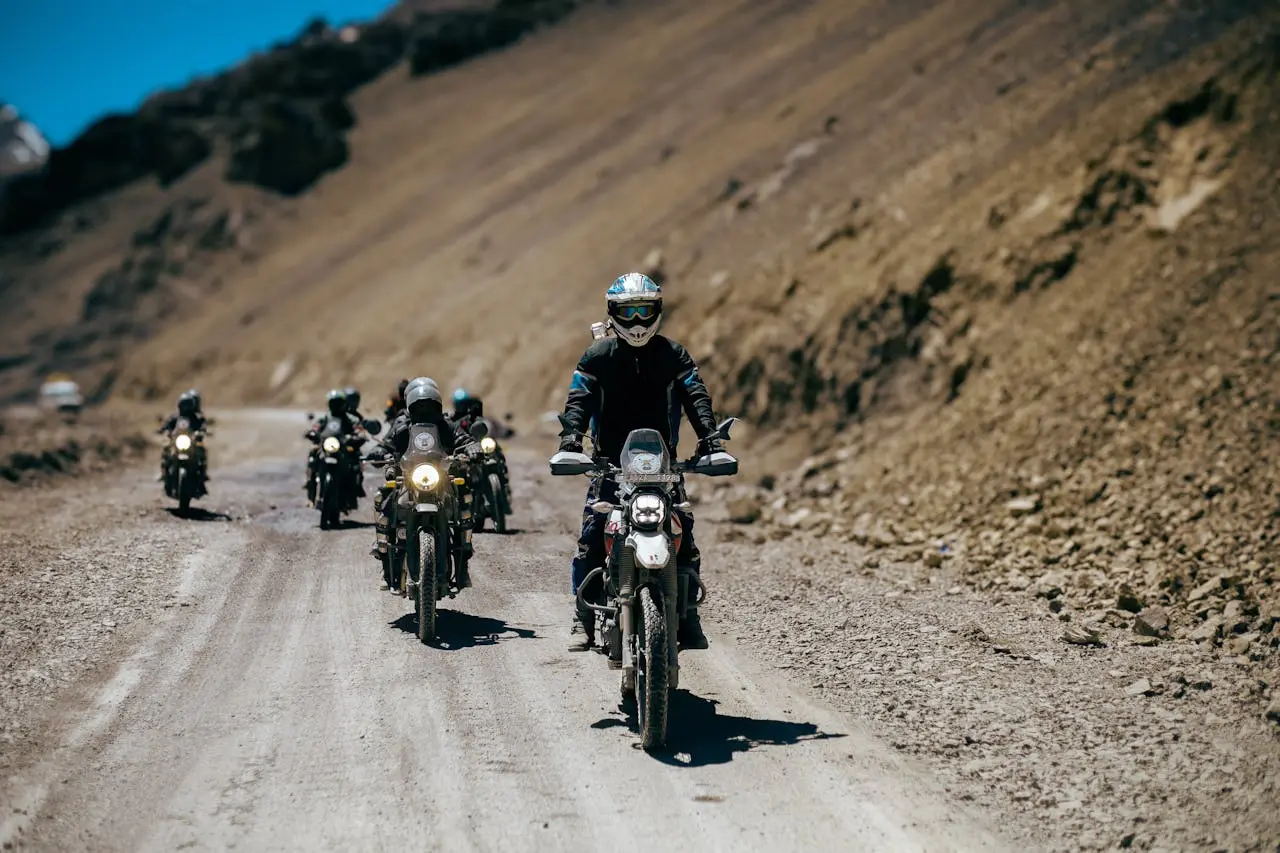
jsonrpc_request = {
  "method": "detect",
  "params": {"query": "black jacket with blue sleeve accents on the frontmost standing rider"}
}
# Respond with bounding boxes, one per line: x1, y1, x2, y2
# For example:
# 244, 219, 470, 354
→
564, 334, 716, 465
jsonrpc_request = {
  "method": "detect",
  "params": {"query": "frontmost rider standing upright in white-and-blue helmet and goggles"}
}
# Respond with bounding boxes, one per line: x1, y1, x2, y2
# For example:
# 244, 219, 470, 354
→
559, 273, 722, 648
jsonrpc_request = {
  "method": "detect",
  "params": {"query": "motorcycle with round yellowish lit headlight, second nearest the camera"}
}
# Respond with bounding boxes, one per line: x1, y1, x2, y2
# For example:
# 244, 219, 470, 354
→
383, 424, 471, 643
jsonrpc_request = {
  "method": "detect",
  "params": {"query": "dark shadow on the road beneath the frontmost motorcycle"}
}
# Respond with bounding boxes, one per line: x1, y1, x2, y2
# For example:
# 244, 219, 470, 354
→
591, 690, 845, 767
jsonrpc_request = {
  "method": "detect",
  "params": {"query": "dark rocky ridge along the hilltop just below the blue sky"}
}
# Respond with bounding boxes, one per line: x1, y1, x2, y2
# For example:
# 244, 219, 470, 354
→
0, 0, 576, 233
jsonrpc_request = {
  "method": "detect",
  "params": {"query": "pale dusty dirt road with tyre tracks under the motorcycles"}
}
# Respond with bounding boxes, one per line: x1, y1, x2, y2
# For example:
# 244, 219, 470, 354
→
0, 411, 1001, 850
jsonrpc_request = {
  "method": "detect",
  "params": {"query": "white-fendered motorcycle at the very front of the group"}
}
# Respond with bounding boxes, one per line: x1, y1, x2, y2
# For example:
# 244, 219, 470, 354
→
550, 416, 737, 751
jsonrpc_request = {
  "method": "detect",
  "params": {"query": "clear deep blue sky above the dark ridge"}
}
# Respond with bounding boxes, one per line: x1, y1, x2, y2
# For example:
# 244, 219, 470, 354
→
0, 0, 390, 145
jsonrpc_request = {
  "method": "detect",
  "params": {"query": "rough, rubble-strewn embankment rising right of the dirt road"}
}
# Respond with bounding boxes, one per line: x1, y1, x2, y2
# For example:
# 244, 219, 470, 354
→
710, 21, 1280, 650
